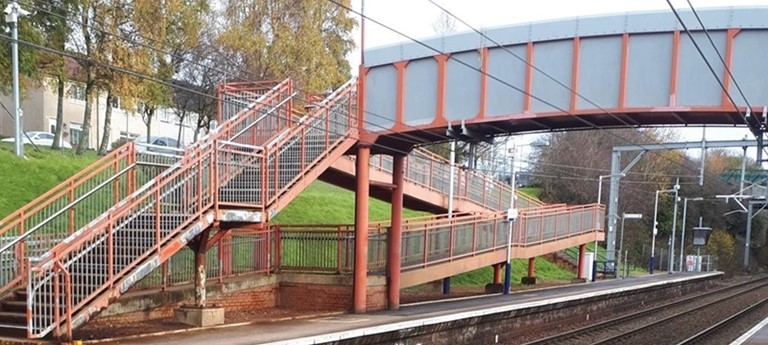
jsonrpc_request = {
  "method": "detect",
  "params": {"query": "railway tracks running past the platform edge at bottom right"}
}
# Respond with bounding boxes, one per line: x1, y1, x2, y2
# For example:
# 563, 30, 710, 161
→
527, 278, 768, 345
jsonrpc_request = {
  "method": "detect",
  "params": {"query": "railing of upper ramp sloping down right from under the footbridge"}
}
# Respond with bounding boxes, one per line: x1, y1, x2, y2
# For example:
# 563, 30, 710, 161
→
360, 149, 543, 211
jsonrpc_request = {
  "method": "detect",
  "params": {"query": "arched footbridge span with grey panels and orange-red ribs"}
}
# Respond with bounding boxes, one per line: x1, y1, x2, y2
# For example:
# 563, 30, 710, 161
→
361, 7, 768, 147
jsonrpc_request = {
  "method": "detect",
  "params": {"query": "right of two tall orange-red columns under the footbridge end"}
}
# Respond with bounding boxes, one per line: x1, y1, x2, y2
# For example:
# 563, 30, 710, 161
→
387, 156, 405, 310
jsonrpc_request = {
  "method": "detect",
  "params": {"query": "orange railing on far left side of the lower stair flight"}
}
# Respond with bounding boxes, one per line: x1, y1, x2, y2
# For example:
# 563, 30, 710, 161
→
0, 142, 137, 297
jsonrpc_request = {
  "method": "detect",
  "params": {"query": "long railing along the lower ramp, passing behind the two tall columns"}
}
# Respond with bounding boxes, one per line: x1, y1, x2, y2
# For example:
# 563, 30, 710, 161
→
123, 204, 604, 290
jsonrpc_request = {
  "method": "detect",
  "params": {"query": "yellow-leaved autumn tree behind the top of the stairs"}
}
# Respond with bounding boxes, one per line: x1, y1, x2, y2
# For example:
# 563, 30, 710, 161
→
216, 0, 355, 92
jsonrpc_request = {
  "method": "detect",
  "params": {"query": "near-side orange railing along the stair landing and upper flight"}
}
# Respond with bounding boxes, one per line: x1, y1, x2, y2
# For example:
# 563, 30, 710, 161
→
217, 79, 357, 218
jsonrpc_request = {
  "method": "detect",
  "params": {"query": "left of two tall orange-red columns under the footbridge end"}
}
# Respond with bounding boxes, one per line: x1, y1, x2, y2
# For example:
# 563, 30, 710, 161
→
352, 146, 371, 313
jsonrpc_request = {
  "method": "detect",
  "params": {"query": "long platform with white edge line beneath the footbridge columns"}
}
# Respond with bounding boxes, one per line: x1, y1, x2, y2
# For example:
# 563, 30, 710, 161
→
90, 272, 721, 345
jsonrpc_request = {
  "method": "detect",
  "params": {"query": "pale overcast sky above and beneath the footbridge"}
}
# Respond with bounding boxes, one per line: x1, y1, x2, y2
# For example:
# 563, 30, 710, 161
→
348, 0, 768, 161
